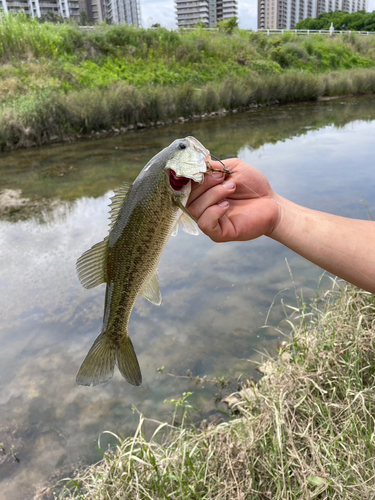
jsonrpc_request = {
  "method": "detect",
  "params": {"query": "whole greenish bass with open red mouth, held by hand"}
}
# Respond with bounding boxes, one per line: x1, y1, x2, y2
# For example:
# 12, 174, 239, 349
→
76, 136, 212, 386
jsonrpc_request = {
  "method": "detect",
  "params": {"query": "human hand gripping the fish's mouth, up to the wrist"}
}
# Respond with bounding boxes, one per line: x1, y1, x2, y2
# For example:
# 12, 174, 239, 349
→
187, 158, 279, 243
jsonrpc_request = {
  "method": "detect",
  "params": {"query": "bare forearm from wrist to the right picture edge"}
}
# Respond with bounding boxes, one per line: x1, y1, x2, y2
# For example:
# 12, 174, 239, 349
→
269, 195, 375, 294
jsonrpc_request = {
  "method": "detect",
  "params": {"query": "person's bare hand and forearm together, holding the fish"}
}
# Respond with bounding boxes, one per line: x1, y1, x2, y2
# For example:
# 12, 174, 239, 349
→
187, 158, 375, 294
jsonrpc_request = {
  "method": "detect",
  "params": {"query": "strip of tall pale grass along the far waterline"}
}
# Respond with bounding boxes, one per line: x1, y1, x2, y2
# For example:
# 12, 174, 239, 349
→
0, 70, 375, 150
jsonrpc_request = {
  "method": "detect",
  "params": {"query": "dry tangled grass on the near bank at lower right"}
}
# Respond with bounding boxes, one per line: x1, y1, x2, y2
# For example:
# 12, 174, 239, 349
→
55, 285, 375, 500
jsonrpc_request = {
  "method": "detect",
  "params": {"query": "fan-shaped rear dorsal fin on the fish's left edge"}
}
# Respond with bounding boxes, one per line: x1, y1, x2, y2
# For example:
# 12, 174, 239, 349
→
77, 236, 108, 288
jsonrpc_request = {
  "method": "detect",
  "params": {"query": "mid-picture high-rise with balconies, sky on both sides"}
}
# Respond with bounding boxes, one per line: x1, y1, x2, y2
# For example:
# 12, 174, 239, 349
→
175, 0, 237, 28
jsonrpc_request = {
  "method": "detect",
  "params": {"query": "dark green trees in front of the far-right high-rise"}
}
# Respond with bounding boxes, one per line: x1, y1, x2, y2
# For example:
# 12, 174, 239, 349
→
296, 10, 375, 31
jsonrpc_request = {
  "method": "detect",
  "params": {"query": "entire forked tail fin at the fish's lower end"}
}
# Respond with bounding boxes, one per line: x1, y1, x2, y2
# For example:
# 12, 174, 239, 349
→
76, 332, 142, 386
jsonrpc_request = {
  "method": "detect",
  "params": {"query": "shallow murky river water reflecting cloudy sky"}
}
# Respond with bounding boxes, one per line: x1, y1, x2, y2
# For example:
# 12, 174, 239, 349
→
0, 98, 375, 500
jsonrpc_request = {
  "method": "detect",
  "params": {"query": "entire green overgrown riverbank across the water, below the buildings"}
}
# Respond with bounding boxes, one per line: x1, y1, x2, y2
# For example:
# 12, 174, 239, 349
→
0, 16, 375, 151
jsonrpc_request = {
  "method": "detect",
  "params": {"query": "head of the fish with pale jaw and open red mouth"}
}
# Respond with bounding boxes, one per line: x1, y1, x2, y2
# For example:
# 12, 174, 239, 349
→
165, 136, 210, 193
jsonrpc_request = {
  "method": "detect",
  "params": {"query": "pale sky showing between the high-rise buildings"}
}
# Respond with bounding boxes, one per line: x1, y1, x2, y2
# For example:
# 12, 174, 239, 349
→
140, 0, 375, 29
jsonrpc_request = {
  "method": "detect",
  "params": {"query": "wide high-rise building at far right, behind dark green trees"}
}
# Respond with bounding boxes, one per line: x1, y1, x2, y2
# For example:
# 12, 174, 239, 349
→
258, 0, 368, 29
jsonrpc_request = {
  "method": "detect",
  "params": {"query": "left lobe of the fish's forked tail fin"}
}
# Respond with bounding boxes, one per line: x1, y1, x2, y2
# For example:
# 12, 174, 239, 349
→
76, 332, 116, 386
